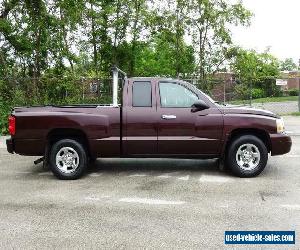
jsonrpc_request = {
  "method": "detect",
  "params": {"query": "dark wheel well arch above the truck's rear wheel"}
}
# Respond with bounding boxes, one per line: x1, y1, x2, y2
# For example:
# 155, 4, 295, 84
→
47, 128, 90, 155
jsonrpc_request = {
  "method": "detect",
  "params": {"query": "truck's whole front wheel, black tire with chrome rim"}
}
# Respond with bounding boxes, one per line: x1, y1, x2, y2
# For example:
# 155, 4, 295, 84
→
226, 135, 268, 177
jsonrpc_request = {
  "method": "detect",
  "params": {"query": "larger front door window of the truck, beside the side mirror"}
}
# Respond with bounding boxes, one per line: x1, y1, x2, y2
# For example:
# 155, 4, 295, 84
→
159, 82, 199, 108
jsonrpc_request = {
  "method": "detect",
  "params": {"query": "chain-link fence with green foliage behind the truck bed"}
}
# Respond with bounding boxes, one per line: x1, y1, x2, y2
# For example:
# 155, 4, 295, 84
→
0, 77, 117, 105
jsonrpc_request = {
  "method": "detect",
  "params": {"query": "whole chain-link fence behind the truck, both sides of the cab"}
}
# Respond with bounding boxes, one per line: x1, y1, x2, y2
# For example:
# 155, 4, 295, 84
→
0, 73, 299, 106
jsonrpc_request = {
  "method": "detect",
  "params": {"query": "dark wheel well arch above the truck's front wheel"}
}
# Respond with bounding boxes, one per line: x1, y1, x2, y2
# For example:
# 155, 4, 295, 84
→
225, 129, 271, 153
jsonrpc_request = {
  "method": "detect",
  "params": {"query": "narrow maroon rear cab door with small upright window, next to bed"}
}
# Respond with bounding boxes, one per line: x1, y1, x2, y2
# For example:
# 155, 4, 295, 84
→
123, 79, 157, 156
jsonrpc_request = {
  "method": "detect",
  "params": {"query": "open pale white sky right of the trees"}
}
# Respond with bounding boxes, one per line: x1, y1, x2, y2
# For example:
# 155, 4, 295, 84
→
232, 0, 300, 64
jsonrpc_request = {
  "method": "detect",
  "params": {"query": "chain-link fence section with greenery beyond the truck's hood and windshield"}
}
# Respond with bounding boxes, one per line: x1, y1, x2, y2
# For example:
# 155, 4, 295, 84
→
183, 73, 300, 109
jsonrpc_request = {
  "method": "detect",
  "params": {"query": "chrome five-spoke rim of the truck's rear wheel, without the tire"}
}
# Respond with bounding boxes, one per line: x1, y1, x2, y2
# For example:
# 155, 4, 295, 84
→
56, 147, 79, 174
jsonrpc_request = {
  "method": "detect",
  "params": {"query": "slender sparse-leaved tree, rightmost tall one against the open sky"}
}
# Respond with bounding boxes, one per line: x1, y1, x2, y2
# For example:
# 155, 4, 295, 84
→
186, 0, 252, 80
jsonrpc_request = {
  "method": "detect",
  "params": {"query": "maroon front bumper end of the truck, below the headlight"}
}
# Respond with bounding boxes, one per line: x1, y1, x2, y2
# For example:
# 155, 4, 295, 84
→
270, 134, 292, 155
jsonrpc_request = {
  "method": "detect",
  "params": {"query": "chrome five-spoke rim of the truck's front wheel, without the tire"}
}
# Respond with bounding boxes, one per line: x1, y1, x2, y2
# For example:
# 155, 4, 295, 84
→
235, 143, 260, 171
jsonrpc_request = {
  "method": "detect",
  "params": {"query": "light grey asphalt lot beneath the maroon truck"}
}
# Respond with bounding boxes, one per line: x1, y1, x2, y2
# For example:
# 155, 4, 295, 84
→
0, 118, 300, 249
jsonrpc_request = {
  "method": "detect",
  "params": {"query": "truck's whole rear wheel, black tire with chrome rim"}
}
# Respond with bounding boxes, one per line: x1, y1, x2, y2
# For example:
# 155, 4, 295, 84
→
49, 139, 87, 180
